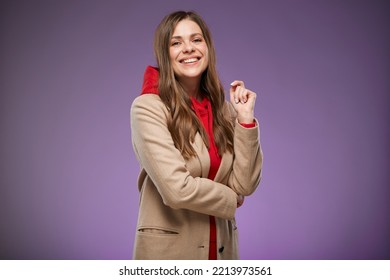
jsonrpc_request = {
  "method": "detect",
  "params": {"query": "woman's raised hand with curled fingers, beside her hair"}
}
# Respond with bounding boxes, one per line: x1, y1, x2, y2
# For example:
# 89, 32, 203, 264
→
230, 81, 256, 123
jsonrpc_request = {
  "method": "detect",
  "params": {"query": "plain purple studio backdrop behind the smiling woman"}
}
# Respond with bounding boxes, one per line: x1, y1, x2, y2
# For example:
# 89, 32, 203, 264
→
0, 0, 390, 259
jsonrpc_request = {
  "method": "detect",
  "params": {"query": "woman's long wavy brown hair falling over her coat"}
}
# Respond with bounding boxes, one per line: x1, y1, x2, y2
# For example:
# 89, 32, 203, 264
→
154, 11, 233, 159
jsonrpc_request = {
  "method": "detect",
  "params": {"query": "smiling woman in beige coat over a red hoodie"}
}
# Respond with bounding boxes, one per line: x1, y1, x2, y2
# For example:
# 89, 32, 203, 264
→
131, 11, 262, 259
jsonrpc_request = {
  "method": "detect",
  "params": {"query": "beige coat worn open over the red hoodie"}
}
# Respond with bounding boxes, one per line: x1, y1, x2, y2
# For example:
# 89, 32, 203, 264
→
131, 94, 263, 260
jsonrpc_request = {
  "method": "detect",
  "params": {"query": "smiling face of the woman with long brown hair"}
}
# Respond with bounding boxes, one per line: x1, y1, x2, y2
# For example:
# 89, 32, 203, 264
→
169, 19, 209, 83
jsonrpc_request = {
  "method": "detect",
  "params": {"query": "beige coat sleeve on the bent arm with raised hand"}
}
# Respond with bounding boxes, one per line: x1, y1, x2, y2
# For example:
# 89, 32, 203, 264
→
227, 103, 263, 196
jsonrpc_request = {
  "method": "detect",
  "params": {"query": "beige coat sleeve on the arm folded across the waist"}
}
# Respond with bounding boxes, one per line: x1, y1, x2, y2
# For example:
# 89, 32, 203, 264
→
131, 94, 237, 219
